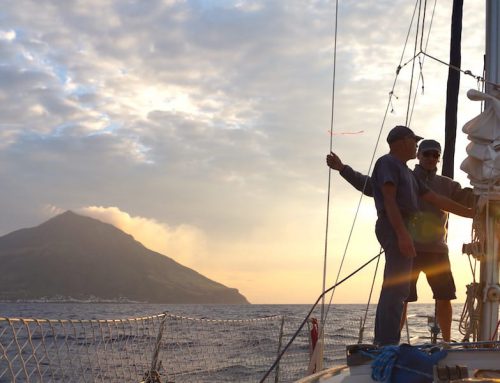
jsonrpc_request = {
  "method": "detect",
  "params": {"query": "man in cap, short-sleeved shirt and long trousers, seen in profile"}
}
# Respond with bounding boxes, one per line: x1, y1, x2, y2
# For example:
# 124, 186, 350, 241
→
326, 125, 474, 346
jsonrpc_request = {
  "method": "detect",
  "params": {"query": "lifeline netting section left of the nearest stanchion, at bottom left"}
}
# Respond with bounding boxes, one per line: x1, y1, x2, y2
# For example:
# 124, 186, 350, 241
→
0, 315, 162, 382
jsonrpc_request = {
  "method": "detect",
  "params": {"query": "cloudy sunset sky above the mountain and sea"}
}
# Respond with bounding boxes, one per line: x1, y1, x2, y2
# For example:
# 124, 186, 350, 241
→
0, 0, 484, 304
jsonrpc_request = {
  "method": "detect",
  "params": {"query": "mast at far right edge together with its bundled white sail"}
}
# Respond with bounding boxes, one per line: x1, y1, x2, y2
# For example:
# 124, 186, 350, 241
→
461, 0, 500, 341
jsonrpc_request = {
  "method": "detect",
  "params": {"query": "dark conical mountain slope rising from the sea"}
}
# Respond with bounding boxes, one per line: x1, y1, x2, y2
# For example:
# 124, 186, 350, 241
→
0, 211, 248, 303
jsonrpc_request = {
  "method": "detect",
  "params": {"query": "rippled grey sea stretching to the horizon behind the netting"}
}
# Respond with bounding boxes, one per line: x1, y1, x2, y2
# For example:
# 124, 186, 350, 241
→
0, 303, 472, 383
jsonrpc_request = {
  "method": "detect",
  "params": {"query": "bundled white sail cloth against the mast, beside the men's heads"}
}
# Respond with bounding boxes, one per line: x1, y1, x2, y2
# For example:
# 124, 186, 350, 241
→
460, 90, 500, 195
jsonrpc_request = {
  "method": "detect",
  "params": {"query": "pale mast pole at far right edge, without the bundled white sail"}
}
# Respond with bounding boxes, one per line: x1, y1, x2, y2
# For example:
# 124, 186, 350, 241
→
479, 0, 500, 340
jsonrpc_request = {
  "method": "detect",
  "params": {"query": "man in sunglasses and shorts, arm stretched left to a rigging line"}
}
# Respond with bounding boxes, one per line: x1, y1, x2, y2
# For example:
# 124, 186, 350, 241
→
326, 140, 475, 342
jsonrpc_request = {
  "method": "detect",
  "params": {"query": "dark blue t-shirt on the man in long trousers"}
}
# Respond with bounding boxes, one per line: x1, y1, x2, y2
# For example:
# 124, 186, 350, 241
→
372, 154, 429, 220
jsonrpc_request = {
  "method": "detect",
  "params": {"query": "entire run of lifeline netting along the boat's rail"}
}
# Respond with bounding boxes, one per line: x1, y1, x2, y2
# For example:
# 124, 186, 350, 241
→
0, 313, 376, 383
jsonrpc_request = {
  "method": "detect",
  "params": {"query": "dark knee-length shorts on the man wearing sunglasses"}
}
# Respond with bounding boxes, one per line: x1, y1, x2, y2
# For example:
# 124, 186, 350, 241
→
406, 252, 457, 302
